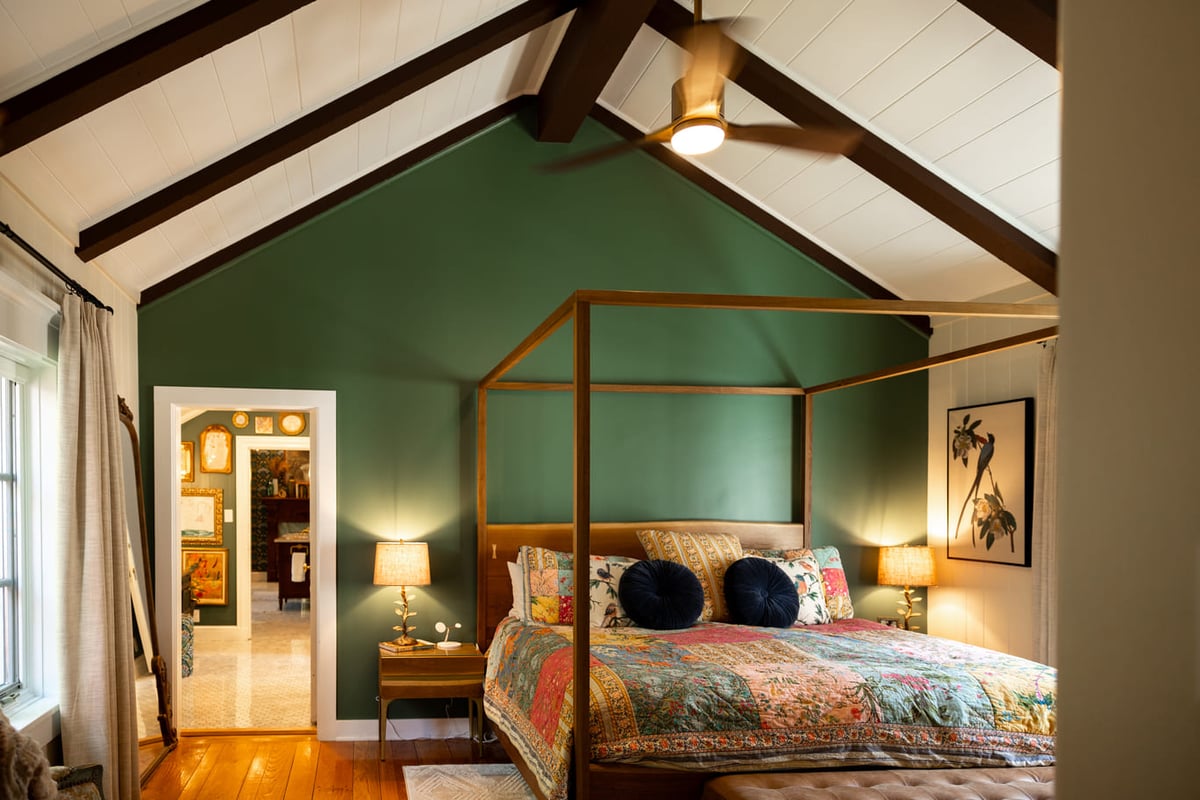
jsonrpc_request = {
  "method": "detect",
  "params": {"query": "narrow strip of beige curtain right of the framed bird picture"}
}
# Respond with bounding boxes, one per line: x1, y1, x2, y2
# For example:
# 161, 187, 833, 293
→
1033, 342, 1058, 666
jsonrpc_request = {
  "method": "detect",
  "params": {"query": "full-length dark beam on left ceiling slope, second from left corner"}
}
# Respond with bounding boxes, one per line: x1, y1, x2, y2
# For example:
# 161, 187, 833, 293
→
76, 0, 578, 261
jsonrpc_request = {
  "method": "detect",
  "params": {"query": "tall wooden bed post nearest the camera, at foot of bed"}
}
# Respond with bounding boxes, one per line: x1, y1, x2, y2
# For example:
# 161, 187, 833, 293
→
572, 302, 592, 800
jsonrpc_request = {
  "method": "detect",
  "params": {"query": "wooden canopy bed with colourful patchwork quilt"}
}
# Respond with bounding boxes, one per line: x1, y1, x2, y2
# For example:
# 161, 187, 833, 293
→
476, 290, 1057, 800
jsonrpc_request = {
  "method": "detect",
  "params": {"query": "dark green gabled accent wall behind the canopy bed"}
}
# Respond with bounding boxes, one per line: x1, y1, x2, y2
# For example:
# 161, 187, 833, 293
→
138, 119, 928, 720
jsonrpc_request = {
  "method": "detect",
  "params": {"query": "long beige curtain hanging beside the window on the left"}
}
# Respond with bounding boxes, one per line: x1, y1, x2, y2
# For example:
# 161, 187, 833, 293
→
59, 295, 140, 800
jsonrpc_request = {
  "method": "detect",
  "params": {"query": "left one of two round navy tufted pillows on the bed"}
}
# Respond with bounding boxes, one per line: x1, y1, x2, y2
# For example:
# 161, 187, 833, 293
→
617, 559, 700, 631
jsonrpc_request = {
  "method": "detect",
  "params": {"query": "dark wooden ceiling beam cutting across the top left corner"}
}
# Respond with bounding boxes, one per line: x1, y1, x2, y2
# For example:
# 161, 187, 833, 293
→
0, 0, 312, 156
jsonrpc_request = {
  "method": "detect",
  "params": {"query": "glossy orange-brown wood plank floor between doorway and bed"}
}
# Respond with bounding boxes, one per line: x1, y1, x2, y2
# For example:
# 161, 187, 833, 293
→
142, 733, 509, 800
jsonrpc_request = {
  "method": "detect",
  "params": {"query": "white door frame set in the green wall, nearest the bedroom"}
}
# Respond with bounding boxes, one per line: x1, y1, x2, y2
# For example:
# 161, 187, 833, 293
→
154, 386, 337, 741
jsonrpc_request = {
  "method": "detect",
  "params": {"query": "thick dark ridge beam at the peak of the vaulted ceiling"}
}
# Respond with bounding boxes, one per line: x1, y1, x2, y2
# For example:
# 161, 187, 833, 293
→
538, 0, 654, 142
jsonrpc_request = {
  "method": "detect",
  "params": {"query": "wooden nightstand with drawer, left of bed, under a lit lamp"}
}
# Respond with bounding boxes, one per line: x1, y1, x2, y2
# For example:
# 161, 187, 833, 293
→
379, 644, 487, 760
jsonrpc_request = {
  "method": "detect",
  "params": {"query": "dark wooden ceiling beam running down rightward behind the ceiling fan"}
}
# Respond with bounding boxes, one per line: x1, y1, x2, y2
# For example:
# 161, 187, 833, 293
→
647, 0, 1058, 293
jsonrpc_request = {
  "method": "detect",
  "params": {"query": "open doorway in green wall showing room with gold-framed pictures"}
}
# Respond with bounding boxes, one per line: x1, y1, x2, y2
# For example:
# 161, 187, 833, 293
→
175, 424, 316, 730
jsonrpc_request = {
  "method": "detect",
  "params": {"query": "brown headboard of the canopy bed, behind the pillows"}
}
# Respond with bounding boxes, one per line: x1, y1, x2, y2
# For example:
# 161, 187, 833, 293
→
475, 519, 809, 649
